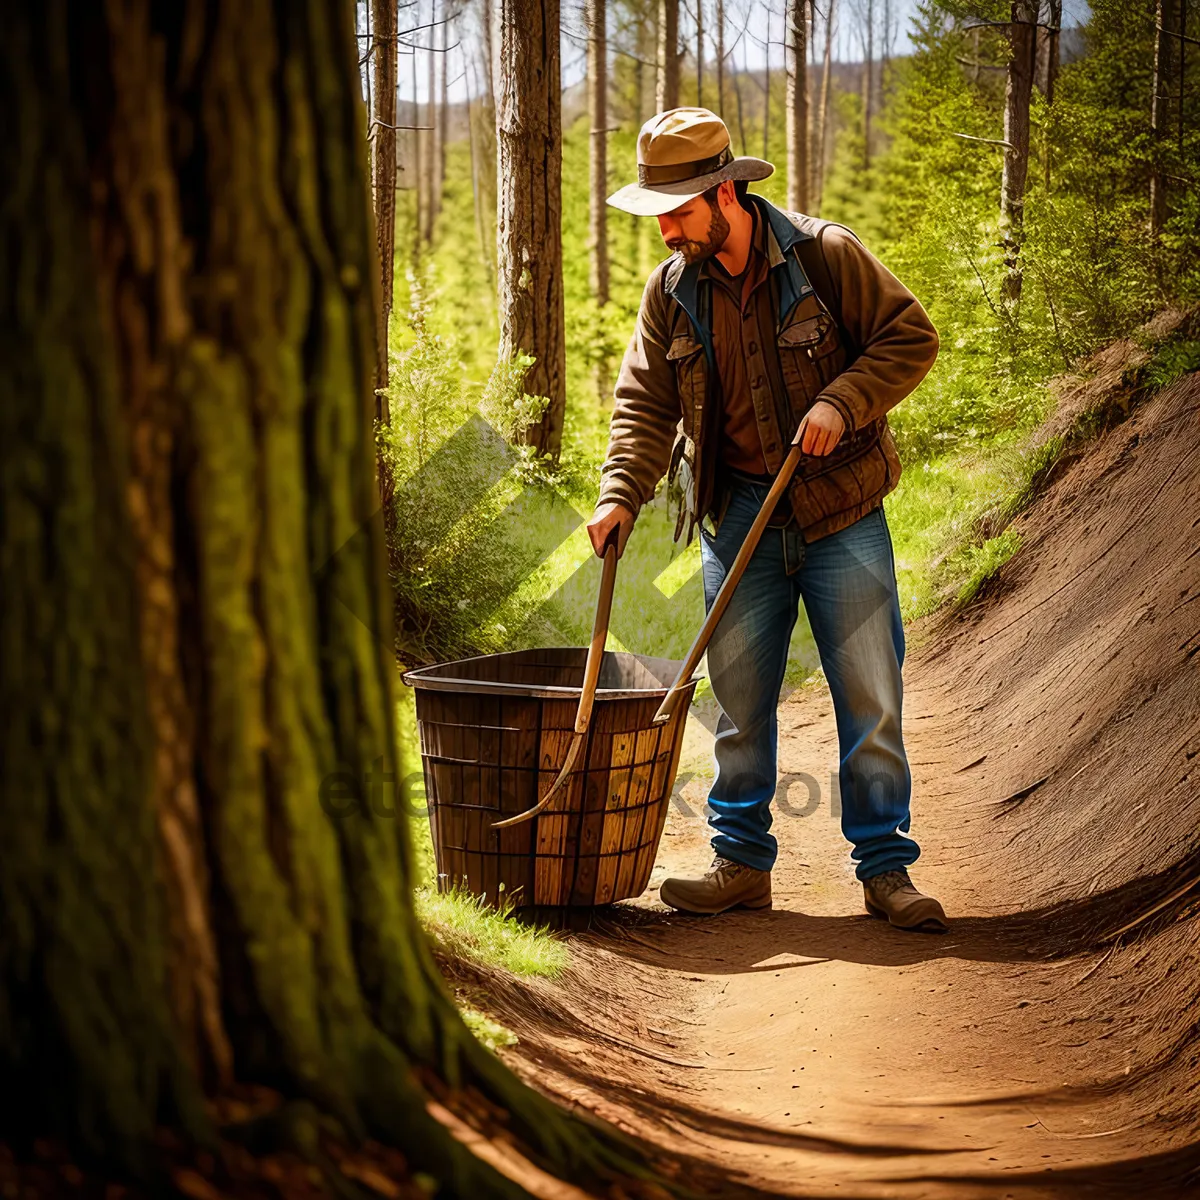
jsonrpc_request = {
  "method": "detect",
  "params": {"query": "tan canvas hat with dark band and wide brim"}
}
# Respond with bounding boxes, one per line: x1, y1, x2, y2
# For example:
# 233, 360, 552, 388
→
608, 108, 775, 217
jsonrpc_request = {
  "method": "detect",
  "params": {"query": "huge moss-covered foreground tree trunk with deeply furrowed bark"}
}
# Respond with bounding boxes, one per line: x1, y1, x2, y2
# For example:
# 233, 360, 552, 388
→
0, 0, 652, 1200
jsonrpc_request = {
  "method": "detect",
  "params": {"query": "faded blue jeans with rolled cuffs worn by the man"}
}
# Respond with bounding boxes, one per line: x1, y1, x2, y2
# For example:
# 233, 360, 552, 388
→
701, 482, 920, 880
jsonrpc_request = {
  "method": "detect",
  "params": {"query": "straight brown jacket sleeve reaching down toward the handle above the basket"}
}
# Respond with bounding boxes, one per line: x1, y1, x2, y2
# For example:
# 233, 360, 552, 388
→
596, 271, 683, 514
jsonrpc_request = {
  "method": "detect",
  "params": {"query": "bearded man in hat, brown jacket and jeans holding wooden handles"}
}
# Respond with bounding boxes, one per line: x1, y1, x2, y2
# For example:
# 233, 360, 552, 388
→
588, 108, 946, 931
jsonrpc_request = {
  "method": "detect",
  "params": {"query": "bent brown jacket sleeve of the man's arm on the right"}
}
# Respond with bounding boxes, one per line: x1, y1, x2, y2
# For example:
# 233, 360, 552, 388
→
817, 226, 938, 434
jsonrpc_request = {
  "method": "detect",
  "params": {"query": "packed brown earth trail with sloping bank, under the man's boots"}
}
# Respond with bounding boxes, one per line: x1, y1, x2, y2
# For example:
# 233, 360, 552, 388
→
475, 347, 1200, 1198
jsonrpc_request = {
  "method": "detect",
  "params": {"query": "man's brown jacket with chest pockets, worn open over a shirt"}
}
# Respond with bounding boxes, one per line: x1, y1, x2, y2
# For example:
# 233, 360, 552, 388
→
599, 196, 938, 541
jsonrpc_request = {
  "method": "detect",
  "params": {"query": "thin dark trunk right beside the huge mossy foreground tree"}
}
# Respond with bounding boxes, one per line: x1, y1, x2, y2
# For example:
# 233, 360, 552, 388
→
371, 0, 398, 405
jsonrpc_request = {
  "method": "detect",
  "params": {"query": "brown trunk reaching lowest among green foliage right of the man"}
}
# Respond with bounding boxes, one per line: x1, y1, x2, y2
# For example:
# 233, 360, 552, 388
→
1000, 0, 1038, 305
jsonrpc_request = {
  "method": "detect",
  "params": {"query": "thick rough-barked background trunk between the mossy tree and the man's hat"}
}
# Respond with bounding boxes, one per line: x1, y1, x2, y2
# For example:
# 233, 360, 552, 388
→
496, 0, 566, 458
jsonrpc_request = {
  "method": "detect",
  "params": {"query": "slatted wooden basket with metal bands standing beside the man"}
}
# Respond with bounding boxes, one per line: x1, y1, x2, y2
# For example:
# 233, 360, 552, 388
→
404, 648, 696, 907
